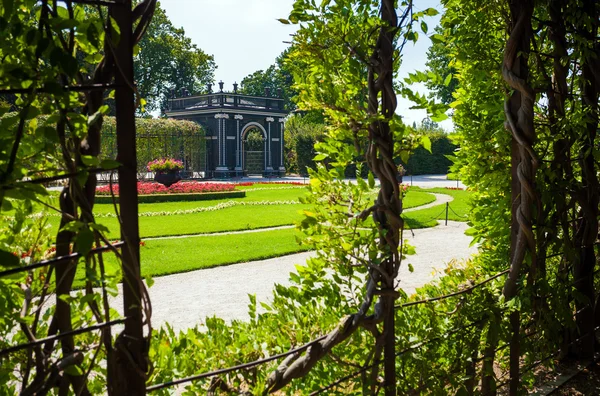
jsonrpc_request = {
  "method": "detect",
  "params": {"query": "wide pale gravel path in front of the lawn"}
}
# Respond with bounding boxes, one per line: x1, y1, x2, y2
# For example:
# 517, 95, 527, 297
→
139, 222, 476, 331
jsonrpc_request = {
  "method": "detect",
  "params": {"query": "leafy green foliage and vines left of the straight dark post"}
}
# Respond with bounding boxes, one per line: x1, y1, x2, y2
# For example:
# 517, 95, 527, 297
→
0, 0, 142, 394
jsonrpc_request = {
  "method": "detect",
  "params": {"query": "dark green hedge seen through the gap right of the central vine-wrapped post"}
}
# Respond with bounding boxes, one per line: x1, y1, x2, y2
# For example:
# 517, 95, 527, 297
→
402, 133, 458, 175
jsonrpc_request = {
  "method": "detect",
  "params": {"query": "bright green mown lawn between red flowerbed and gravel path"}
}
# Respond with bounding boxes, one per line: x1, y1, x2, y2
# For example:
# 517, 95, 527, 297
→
62, 188, 469, 286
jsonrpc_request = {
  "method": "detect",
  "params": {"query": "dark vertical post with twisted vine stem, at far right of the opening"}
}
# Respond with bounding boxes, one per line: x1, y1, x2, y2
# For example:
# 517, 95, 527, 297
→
502, 0, 536, 395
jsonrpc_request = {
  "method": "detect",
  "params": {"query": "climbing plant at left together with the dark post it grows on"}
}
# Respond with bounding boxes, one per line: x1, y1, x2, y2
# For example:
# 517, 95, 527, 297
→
0, 0, 156, 395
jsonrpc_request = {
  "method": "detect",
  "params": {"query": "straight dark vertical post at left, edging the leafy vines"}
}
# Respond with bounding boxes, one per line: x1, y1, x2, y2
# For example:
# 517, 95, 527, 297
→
110, 0, 147, 395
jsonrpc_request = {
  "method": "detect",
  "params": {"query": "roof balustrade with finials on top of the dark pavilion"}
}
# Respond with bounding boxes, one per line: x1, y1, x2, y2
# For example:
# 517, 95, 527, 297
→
168, 92, 284, 112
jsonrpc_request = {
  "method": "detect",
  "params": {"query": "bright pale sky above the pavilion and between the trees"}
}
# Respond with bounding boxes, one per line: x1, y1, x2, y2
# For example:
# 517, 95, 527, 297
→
160, 0, 452, 129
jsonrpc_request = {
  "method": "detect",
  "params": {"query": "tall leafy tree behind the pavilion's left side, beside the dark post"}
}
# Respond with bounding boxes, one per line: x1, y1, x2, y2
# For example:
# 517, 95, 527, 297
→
134, 3, 216, 112
